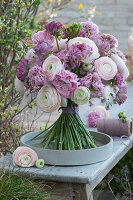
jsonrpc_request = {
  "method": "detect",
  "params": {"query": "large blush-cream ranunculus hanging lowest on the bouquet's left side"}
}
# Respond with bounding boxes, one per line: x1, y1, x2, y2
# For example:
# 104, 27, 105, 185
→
36, 85, 61, 112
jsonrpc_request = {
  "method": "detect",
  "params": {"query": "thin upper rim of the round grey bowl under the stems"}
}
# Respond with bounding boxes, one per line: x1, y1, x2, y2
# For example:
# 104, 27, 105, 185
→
20, 130, 113, 152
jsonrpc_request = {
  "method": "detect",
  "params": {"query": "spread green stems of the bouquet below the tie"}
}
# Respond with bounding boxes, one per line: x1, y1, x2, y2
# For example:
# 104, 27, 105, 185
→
33, 106, 96, 150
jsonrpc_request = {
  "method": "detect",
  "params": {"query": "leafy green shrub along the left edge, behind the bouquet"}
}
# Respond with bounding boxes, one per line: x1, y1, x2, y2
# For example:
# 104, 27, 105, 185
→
0, 0, 41, 154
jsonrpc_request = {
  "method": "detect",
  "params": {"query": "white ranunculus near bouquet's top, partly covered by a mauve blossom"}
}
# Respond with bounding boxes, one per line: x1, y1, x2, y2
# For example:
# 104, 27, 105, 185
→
68, 37, 99, 63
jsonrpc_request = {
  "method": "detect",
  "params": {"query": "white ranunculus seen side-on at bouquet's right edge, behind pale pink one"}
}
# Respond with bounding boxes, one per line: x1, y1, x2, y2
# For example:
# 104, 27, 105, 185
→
111, 53, 129, 79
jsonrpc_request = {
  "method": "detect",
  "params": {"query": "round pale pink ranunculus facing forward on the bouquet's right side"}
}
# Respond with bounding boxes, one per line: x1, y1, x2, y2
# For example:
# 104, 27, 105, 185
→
95, 56, 117, 80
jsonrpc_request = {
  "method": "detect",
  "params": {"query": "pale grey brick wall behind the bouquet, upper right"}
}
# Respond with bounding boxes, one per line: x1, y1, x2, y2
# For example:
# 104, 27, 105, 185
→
53, 0, 133, 52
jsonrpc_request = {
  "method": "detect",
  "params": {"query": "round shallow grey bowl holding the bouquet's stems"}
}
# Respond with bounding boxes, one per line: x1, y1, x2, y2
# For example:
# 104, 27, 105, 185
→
20, 131, 113, 166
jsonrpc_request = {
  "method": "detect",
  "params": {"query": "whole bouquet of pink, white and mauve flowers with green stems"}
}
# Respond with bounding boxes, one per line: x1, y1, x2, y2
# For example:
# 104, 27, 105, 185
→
16, 21, 128, 150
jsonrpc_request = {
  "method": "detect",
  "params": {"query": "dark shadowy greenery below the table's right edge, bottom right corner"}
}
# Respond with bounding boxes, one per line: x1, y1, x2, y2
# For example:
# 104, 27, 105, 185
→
97, 148, 133, 200
